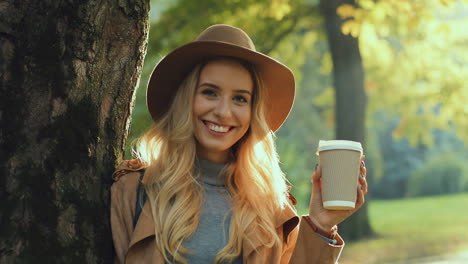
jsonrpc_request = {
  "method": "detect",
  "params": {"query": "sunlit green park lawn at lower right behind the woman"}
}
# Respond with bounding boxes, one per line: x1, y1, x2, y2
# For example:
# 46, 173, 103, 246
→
340, 193, 468, 264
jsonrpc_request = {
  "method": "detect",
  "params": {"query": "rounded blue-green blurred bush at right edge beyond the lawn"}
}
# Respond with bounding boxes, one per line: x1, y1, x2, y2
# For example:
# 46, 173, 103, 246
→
407, 154, 468, 197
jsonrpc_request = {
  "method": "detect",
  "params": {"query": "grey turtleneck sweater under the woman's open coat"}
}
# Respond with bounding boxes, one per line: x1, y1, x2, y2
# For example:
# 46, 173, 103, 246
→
183, 159, 242, 264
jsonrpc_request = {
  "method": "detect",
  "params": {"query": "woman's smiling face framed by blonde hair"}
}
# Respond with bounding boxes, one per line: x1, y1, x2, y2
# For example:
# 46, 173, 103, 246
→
193, 59, 254, 163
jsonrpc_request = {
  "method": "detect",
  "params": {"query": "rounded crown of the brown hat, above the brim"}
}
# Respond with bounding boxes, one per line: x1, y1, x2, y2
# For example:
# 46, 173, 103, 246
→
196, 25, 256, 51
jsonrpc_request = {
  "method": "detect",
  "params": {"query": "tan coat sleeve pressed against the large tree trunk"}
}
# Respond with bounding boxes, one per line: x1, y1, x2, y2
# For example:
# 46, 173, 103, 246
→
110, 160, 144, 263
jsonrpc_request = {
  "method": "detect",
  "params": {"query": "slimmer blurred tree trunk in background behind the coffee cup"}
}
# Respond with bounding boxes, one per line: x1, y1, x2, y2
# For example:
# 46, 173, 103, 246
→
320, 0, 372, 240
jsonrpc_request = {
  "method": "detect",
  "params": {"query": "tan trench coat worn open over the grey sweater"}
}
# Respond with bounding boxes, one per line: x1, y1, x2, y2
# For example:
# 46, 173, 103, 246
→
111, 160, 344, 264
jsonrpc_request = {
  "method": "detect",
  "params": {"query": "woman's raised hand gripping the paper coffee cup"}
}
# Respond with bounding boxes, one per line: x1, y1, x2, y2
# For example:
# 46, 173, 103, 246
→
309, 156, 367, 231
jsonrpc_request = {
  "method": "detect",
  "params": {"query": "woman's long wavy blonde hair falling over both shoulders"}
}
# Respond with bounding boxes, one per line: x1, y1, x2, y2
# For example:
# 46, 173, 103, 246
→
138, 58, 287, 263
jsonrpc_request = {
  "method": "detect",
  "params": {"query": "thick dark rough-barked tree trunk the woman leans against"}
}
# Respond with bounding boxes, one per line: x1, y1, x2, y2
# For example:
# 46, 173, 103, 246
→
0, 0, 149, 263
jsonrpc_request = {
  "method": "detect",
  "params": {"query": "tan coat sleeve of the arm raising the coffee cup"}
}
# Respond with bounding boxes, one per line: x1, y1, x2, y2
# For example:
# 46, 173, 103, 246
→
281, 217, 344, 264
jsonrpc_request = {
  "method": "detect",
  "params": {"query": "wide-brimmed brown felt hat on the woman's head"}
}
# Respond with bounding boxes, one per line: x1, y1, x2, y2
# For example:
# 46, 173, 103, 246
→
146, 25, 295, 131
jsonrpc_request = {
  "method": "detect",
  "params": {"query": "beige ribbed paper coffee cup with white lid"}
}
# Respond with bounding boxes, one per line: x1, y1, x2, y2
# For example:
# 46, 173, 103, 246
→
317, 140, 362, 210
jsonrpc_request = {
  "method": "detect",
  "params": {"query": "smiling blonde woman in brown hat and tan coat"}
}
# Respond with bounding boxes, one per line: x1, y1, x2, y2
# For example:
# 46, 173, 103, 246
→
111, 25, 367, 263
